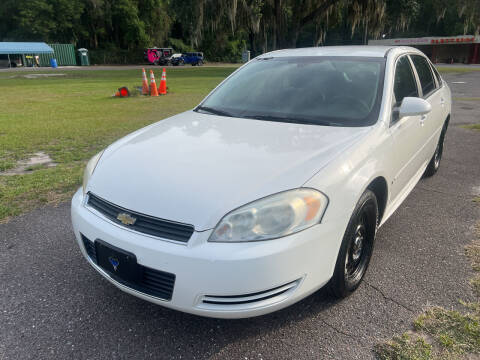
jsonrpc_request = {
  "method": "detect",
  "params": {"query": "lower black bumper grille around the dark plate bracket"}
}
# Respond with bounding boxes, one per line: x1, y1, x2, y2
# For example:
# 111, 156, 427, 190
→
82, 235, 175, 300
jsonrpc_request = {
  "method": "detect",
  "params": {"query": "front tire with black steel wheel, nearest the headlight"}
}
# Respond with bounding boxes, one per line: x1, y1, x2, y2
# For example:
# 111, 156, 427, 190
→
329, 190, 378, 298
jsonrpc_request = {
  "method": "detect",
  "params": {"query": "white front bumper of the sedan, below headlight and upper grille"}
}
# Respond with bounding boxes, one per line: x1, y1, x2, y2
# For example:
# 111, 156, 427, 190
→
71, 189, 348, 318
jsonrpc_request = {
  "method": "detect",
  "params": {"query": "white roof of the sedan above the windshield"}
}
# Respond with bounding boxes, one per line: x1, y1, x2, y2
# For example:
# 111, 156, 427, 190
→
259, 45, 419, 58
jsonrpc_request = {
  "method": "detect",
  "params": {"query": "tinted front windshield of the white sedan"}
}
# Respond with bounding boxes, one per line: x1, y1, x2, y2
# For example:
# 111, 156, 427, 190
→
196, 56, 385, 126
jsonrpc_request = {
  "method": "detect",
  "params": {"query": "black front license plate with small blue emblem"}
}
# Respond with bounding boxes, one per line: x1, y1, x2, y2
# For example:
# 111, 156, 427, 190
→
95, 239, 142, 283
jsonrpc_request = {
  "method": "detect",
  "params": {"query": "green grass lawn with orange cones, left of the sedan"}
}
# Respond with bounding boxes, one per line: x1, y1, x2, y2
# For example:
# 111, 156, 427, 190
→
0, 67, 235, 221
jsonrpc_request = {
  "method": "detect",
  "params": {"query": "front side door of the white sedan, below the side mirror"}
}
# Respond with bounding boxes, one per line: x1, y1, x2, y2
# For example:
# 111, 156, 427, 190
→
389, 55, 425, 200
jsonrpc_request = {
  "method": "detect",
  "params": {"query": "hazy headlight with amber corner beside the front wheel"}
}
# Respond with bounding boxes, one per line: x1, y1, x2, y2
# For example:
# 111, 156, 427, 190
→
208, 188, 328, 242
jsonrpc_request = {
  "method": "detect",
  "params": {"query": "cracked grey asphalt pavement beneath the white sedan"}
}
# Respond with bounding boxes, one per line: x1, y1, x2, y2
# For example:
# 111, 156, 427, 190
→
0, 72, 480, 359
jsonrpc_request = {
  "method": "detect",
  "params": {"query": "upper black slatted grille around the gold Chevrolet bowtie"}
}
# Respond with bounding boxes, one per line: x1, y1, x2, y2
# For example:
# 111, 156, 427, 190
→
87, 193, 194, 242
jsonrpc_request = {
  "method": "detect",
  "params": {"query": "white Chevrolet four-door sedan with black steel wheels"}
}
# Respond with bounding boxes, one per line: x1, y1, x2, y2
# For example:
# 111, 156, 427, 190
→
72, 46, 451, 318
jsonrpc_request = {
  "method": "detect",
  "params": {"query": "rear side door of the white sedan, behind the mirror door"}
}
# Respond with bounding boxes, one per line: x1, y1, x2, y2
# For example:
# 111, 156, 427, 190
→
410, 55, 446, 162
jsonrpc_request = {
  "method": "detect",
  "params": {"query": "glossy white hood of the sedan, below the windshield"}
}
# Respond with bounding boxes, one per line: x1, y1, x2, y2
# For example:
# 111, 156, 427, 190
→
87, 111, 370, 231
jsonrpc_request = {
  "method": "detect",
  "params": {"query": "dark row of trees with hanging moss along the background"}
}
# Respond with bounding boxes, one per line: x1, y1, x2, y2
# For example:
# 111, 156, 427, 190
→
0, 0, 480, 60
